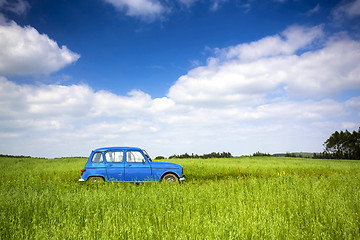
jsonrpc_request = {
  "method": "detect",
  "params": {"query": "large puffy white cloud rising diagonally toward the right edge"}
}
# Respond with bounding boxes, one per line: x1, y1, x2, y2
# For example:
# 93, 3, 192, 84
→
168, 26, 360, 106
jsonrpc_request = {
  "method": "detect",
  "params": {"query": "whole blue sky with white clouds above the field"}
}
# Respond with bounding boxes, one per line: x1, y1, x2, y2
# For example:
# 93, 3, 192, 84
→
0, 0, 360, 158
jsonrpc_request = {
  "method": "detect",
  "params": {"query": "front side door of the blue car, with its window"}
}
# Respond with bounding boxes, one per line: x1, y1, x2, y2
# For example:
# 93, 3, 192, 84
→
125, 150, 151, 182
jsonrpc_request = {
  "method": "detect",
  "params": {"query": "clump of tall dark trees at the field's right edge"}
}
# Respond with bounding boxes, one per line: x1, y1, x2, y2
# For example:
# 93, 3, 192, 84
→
324, 127, 360, 160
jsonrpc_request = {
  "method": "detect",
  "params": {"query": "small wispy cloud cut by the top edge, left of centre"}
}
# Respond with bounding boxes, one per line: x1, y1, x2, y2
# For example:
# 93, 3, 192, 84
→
105, 0, 166, 20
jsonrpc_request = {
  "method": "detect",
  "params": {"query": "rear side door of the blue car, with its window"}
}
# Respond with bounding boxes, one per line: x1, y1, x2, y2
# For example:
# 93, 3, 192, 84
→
105, 151, 125, 181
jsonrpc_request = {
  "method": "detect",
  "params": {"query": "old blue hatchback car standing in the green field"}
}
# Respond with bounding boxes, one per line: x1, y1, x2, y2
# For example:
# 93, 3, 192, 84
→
79, 147, 185, 182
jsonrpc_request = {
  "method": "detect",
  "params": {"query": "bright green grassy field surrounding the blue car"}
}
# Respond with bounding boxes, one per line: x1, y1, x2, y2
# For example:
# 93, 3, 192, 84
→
0, 157, 360, 239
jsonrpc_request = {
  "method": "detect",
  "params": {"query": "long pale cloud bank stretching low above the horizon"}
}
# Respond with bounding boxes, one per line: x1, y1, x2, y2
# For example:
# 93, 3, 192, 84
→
0, 74, 357, 157
